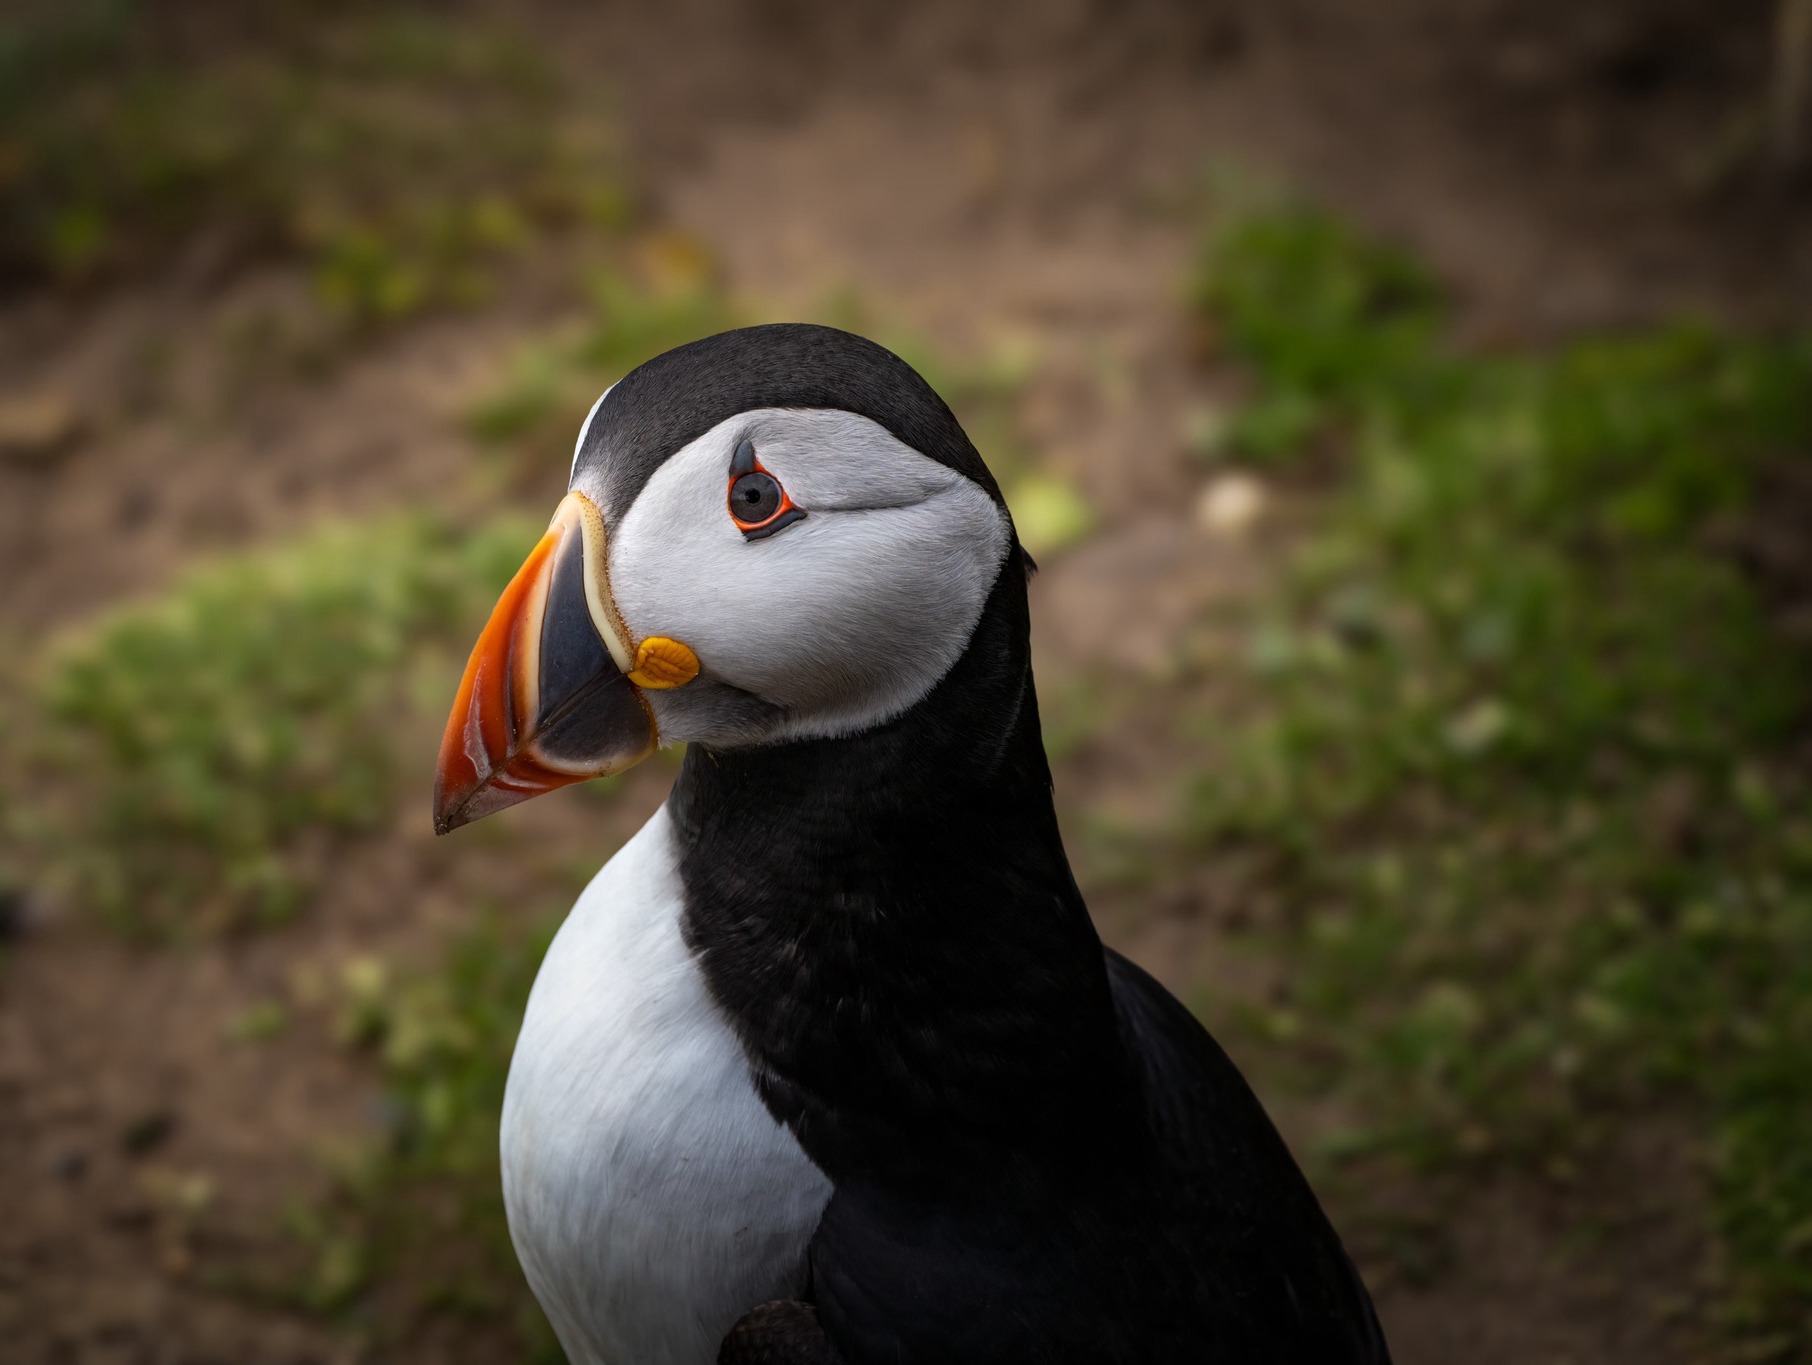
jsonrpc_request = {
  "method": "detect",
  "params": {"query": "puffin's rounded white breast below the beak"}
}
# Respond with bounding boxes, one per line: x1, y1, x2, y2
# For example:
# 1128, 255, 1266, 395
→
502, 808, 830, 1365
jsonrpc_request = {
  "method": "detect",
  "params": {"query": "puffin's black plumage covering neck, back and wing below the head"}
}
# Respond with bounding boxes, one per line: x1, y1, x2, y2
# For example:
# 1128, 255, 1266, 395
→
672, 558, 1388, 1365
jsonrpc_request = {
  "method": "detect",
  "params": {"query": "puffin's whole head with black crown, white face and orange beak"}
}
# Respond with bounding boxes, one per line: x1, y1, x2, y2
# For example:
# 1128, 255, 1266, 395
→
435, 323, 1020, 834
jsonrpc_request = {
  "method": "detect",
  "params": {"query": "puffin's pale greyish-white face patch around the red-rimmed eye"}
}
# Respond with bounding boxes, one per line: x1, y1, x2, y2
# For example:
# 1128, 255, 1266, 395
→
573, 408, 1011, 745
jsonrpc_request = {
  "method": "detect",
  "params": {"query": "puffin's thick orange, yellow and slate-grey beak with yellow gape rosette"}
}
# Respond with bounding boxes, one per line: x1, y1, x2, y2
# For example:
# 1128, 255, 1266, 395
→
435, 493, 698, 834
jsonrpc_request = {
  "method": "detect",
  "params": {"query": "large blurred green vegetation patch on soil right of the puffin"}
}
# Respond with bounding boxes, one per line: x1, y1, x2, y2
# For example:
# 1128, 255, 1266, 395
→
1187, 208, 1812, 1360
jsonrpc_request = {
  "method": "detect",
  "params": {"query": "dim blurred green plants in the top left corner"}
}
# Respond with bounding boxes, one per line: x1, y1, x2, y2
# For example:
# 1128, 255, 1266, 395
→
0, 4, 627, 324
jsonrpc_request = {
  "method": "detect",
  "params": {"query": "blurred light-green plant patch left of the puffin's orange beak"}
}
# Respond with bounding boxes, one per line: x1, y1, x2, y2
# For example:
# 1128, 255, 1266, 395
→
28, 517, 533, 935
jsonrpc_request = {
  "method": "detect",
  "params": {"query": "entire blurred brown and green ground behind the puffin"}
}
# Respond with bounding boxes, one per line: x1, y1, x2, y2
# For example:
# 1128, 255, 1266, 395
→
0, 0, 1812, 1365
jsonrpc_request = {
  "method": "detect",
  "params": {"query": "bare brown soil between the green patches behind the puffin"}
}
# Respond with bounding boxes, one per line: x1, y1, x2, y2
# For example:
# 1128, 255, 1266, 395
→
0, 0, 1812, 1365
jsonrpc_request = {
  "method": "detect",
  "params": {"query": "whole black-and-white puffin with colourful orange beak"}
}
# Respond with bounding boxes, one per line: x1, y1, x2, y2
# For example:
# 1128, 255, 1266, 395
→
435, 323, 1388, 1365
